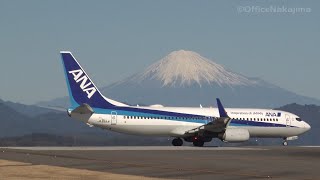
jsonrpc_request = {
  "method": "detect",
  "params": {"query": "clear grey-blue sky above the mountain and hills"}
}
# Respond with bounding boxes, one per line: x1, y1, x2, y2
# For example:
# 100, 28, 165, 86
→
0, 0, 320, 104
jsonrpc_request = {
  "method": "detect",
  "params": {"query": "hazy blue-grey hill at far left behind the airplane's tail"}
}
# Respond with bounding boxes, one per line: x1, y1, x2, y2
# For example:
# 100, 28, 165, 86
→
0, 102, 99, 137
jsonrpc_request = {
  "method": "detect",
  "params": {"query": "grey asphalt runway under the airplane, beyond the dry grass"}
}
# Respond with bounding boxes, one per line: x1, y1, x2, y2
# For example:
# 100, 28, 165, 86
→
0, 146, 320, 179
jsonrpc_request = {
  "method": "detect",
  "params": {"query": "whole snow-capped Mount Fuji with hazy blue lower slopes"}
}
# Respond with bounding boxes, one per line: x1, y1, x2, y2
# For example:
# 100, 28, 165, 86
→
40, 50, 320, 108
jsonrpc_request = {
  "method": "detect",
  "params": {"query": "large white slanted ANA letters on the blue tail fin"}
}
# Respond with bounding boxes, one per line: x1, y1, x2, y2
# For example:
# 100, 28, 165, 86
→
69, 69, 97, 99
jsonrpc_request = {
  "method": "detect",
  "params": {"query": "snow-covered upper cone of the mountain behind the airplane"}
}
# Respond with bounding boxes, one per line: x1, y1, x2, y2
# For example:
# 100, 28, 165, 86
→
134, 50, 254, 86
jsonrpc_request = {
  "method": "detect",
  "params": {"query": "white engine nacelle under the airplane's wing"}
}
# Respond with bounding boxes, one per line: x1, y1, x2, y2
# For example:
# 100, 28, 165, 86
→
219, 128, 250, 142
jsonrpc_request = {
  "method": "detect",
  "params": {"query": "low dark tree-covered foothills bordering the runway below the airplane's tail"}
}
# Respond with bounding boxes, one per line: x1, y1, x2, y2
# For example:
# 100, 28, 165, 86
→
0, 131, 171, 146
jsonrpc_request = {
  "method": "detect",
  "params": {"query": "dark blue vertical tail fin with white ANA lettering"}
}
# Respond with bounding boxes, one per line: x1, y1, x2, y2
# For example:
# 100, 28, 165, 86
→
60, 51, 114, 109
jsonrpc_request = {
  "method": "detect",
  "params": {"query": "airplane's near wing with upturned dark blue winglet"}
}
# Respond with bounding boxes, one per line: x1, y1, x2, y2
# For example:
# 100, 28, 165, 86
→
186, 98, 231, 134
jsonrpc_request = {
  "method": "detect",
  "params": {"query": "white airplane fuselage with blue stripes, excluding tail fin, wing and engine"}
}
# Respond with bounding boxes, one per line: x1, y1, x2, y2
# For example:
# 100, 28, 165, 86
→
72, 106, 310, 137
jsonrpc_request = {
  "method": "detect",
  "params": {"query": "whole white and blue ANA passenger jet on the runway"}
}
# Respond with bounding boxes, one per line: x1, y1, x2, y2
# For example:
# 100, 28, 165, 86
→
60, 51, 311, 147
